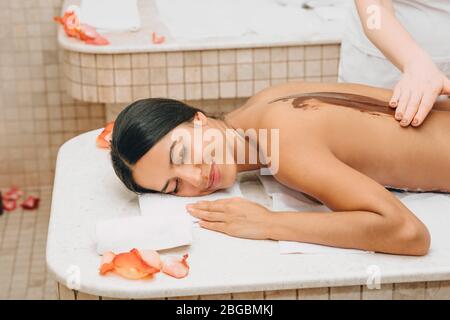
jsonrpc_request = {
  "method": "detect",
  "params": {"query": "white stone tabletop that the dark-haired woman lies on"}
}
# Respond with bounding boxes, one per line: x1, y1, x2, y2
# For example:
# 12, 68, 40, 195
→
47, 129, 450, 298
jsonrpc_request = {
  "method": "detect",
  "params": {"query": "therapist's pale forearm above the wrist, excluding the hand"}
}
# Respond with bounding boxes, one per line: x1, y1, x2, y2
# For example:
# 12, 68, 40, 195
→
355, 0, 428, 72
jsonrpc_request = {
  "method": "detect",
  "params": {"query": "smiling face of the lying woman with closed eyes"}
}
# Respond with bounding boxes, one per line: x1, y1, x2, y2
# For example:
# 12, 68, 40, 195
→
132, 112, 237, 196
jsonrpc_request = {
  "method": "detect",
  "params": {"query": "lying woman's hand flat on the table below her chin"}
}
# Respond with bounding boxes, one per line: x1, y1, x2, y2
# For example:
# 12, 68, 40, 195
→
186, 197, 273, 239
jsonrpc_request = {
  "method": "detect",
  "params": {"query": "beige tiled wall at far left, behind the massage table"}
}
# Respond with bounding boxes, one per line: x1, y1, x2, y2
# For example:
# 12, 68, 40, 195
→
0, 0, 105, 187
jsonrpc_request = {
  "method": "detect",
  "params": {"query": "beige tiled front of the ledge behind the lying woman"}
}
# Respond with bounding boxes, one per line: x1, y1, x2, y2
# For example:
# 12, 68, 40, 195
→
64, 44, 340, 103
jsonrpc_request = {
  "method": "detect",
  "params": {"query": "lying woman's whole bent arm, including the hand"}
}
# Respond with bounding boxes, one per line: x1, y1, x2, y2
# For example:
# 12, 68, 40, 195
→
187, 145, 430, 255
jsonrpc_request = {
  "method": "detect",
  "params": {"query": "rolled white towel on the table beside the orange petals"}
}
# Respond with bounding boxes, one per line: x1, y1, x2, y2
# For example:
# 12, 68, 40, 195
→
95, 215, 192, 254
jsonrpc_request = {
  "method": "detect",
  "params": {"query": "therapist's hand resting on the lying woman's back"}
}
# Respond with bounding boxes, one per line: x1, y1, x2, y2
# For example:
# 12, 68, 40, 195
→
389, 56, 450, 127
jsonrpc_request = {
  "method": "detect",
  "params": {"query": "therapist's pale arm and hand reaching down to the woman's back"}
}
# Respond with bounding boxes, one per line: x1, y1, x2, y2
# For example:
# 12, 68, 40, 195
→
355, 0, 450, 126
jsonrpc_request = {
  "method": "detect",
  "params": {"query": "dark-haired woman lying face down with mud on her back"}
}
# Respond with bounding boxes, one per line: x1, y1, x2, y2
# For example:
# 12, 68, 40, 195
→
111, 82, 450, 255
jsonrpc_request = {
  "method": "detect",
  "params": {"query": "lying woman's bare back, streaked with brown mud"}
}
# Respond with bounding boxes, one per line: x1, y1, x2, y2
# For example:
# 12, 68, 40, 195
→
229, 83, 450, 192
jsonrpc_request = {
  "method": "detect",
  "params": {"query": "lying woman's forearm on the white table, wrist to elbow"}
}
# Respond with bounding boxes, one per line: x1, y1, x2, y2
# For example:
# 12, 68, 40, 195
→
268, 211, 426, 255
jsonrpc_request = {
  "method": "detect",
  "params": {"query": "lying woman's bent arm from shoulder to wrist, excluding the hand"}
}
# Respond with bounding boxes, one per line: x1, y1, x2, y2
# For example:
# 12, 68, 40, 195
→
268, 148, 430, 255
